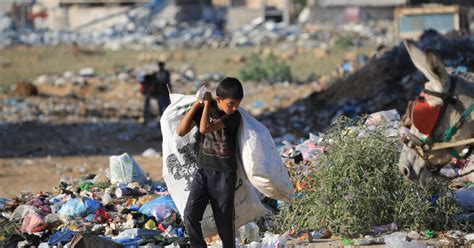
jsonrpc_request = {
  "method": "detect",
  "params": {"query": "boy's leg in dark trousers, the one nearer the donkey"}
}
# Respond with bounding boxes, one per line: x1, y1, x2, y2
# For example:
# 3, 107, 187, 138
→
208, 171, 237, 248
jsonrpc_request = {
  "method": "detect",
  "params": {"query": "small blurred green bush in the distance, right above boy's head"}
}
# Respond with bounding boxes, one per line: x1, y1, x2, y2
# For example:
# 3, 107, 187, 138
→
239, 53, 292, 83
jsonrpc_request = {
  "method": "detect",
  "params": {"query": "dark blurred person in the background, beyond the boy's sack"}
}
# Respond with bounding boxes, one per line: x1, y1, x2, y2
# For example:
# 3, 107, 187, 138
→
138, 61, 171, 124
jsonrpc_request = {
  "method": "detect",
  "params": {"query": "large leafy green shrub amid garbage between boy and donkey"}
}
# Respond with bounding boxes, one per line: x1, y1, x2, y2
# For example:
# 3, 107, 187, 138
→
273, 119, 460, 237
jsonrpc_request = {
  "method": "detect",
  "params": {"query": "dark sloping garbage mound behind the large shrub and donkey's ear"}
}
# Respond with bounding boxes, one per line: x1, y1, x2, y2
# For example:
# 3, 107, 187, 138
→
260, 30, 474, 139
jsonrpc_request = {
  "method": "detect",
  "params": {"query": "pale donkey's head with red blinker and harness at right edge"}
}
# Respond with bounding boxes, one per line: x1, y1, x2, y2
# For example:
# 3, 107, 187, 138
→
398, 40, 474, 187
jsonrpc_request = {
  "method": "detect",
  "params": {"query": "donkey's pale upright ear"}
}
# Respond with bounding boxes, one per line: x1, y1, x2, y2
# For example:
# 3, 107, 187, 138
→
403, 40, 447, 92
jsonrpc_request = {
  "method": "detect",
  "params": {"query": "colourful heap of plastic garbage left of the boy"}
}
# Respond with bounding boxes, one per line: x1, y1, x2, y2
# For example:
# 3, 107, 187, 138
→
0, 153, 187, 247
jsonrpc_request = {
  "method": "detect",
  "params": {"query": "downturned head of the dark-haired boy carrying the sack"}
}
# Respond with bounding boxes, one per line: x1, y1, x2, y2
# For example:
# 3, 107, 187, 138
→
216, 77, 244, 114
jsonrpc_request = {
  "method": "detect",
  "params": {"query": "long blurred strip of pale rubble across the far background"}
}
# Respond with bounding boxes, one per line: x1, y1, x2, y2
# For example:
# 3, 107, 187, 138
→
0, 10, 393, 50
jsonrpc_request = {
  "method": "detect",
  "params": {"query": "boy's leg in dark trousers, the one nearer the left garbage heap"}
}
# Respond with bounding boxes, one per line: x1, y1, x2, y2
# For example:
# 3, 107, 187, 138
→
184, 169, 209, 247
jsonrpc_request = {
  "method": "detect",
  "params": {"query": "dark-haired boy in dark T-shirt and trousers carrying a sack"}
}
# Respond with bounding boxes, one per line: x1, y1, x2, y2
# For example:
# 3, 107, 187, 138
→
177, 77, 244, 248
